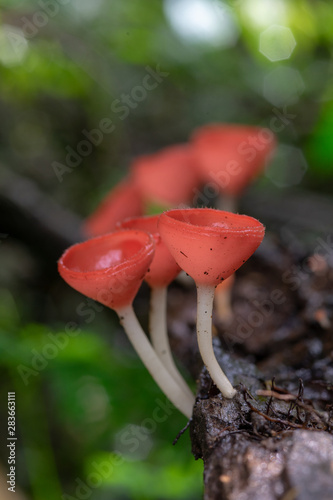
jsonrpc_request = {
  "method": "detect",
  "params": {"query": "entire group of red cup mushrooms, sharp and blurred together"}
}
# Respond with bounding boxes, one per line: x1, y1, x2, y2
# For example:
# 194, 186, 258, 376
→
58, 124, 276, 418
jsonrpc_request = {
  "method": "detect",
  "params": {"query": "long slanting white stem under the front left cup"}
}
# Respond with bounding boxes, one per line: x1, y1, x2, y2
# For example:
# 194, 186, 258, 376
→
116, 306, 194, 418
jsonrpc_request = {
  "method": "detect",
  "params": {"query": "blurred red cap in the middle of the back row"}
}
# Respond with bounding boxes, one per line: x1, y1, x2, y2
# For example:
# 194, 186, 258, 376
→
132, 144, 199, 206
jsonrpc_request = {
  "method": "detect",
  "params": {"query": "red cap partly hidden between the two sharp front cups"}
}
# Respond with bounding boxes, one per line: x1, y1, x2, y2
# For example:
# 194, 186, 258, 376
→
119, 215, 181, 287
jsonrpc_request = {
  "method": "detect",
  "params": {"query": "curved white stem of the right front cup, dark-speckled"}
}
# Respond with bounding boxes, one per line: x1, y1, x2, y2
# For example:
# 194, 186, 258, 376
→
197, 285, 236, 399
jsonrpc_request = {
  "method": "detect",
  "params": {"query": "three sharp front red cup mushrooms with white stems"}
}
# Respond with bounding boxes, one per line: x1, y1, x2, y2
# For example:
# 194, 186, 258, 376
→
58, 209, 264, 418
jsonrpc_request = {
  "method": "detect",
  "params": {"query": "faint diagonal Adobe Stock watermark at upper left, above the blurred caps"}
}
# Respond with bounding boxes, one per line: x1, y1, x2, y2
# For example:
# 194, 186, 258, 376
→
51, 65, 170, 182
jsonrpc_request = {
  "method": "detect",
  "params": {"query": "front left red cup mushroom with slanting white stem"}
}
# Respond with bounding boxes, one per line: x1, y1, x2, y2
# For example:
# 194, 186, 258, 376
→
58, 230, 193, 417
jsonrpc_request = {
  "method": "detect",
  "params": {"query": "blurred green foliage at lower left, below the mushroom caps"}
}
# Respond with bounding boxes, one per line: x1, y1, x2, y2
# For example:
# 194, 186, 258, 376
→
0, 291, 202, 500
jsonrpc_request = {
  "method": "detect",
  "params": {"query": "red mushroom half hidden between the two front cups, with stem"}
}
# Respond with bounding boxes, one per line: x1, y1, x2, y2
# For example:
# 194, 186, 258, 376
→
119, 215, 194, 403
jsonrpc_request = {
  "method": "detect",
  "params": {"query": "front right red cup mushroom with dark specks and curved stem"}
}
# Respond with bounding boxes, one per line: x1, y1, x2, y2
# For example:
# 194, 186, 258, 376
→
159, 208, 265, 398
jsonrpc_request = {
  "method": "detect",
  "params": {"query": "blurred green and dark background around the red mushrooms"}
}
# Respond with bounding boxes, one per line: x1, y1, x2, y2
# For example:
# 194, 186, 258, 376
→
0, 0, 333, 500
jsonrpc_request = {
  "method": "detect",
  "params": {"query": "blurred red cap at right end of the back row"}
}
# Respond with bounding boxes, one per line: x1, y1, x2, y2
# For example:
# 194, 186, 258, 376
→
192, 124, 276, 196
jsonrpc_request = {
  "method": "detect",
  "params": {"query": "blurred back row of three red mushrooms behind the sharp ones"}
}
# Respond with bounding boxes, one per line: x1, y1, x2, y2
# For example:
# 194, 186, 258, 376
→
83, 123, 277, 322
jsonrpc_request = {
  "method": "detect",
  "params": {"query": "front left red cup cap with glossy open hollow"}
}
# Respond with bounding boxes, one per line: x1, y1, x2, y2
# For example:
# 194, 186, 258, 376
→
58, 230, 155, 310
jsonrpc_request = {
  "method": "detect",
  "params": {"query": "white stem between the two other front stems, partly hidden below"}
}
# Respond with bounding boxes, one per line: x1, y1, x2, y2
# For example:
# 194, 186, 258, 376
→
149, 287, 194, 398
